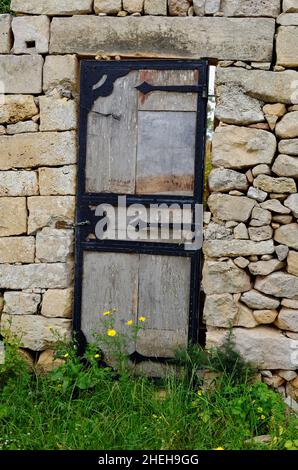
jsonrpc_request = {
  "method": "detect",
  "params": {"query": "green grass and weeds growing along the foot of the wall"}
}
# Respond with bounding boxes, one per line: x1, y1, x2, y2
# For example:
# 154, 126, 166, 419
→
0, 334, 298, 450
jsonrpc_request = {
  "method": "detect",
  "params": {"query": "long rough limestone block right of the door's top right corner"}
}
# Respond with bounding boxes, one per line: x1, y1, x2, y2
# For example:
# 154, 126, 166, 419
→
216, 67, 298, 104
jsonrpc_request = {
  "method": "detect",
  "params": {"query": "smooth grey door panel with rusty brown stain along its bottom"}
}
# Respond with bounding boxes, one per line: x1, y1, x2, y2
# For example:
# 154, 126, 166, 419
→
136, 111, 196, 195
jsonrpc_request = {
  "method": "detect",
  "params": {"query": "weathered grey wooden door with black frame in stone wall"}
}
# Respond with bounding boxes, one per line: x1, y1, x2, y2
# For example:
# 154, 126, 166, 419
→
74, 61, 207, 360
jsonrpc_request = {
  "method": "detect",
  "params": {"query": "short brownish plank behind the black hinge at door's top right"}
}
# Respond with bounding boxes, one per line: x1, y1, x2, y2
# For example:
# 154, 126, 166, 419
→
139, 70, 198, 111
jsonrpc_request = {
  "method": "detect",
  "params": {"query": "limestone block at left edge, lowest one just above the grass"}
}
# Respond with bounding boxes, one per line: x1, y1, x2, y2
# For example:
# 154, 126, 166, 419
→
1, 314, 71, 351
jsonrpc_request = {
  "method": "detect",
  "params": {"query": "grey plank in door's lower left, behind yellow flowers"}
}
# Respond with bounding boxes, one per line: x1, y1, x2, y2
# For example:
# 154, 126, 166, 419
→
82, 252, 139, 353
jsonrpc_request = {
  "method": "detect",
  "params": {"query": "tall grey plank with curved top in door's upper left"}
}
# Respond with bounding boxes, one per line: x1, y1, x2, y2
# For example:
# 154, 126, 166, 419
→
86, 72, 138, 194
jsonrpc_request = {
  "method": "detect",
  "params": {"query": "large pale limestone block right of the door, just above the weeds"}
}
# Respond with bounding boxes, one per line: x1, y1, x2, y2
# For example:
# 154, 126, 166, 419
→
207, 326, 298, 370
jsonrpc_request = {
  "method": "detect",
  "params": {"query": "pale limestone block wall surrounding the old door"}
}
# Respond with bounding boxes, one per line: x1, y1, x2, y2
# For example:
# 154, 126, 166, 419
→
0, 0, 298, 394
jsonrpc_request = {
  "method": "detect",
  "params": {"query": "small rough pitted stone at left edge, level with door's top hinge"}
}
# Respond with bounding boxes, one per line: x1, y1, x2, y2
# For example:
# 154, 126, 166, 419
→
0, 95, 38, 124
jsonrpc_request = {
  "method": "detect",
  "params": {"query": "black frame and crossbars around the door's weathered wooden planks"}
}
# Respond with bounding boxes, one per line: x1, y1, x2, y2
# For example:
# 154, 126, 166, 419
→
73, 60, 208, 360
